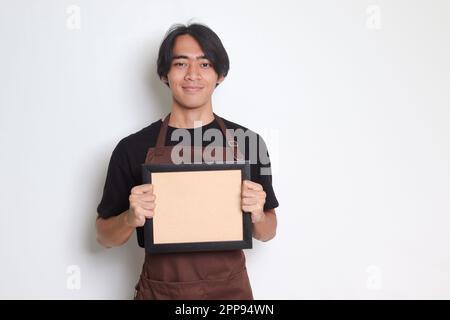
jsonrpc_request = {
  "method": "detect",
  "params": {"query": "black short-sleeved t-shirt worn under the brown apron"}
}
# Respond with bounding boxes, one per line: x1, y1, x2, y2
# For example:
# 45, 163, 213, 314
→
97, 118, 278, 245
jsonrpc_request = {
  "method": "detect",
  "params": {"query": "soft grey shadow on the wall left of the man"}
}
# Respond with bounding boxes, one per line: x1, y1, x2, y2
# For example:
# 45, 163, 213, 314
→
84, 41, 172, 299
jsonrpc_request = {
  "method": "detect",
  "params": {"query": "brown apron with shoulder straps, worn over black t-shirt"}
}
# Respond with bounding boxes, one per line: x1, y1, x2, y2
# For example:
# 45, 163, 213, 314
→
134, 113, 253, 300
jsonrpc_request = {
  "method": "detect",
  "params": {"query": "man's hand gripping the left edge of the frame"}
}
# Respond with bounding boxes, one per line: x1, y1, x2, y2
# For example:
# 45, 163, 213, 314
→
125, 183, 156, 228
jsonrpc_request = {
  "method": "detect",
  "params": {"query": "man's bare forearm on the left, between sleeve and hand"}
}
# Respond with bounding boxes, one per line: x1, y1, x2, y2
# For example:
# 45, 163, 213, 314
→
95, 211, 135, 248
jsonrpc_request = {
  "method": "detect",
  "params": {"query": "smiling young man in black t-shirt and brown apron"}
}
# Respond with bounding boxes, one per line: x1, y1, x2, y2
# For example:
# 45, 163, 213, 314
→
96, 24, 278, 299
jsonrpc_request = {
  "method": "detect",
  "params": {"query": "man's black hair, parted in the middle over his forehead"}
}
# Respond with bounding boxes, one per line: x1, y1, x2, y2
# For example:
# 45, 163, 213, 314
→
157, 23, 230, 87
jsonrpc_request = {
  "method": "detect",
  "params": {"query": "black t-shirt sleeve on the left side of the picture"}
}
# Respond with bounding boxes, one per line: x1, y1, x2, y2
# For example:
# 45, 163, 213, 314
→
97, 141, 133, 218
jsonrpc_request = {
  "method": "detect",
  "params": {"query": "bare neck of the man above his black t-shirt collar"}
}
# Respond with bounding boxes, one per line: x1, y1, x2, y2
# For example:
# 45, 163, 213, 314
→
169, 101, 214, 128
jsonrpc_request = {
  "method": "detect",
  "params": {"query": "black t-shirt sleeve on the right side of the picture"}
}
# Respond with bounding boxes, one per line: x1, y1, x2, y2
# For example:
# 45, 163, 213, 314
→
251, 135, 279, 211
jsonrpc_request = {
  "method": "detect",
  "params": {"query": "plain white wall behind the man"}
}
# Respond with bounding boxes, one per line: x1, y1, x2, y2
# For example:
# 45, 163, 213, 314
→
0, 0, 450, 299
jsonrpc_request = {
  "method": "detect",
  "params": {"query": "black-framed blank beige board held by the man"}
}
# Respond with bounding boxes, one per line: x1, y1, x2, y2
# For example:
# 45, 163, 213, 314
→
142, 161, 252, 253
